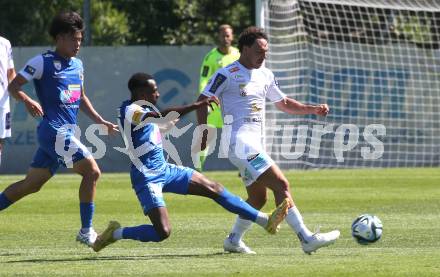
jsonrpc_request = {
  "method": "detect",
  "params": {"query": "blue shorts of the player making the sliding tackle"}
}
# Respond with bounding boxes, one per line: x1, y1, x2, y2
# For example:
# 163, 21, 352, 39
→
130, 164, 194, 214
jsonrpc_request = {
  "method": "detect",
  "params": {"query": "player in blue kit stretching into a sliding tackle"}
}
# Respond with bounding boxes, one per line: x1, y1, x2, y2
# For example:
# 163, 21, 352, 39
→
93, 73, 290, 252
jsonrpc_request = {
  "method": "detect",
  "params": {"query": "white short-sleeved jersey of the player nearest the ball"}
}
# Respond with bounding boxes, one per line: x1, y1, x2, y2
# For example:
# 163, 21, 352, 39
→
203, 61, 286, 153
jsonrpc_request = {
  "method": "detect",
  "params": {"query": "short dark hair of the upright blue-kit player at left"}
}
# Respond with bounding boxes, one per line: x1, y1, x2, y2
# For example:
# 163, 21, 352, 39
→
49, 12, 84, 39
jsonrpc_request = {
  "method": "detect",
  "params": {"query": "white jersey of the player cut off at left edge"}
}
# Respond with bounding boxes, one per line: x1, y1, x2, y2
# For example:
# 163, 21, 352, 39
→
0, 37, 14, 110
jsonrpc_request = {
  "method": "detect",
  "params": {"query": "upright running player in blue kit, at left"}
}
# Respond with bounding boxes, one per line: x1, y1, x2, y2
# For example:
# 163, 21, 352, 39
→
0, 12, 117, 246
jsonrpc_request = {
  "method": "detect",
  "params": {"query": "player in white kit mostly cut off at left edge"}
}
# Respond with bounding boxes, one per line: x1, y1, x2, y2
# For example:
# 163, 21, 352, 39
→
0, 37, 15, 165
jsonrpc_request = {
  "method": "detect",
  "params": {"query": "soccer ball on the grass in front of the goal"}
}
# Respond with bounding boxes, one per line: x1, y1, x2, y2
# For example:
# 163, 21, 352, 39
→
351, 214, 382, 244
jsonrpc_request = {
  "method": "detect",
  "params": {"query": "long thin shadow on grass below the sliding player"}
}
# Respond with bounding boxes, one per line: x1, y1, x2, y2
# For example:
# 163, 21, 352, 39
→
4, 252, 231, 263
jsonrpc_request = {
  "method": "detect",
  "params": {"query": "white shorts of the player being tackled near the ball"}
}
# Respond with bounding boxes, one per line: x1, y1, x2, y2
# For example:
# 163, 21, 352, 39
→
229, 151, 275, 186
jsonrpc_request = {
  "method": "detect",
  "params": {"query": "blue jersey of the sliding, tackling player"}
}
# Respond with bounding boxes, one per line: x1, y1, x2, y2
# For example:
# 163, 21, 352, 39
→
118, 100, 167, 171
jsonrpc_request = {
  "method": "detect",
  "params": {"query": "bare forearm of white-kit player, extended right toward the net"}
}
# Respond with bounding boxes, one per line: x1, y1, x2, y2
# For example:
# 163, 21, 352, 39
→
275, 97, 330, 116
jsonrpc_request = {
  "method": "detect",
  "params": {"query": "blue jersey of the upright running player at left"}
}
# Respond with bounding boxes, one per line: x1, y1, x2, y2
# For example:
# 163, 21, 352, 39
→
19, 51, 84, 129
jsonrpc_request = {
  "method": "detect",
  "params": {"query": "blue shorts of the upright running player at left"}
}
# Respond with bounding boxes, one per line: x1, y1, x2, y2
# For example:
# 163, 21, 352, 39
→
31, 121, 91, 175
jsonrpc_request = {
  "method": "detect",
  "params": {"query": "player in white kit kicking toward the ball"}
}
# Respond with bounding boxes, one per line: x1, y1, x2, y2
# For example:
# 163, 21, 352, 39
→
197, 27, 340, 254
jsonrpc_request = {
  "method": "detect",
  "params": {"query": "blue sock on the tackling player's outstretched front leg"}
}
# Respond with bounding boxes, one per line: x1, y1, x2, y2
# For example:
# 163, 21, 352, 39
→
214, 188, 258, 222
